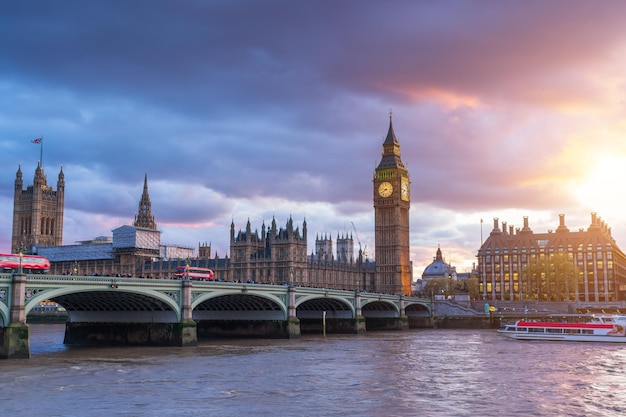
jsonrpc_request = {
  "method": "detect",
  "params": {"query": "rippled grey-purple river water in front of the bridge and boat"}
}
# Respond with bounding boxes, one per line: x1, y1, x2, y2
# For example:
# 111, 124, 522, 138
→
0, 324, 626, 417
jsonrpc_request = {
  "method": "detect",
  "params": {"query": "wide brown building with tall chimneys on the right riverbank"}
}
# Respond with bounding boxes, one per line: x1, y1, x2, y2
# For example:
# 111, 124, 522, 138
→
478, 213, 626, 302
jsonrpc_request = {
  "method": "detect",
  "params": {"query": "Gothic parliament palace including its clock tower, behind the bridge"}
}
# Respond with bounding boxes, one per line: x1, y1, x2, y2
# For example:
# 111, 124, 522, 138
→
11, 115, 413, 295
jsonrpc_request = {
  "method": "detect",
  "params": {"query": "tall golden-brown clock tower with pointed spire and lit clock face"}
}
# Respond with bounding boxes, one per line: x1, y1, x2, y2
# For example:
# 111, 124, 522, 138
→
374, 114, 412, 295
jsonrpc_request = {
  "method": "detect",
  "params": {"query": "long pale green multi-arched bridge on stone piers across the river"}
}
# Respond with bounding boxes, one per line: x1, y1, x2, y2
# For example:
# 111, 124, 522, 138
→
0, 274, 432, 359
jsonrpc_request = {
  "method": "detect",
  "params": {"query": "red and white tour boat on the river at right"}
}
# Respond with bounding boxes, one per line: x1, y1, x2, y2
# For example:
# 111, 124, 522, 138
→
498, 314, 626, 343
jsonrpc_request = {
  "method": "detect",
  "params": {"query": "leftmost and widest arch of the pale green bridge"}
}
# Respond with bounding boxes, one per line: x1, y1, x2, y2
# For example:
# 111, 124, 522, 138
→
24, 286, 181, 323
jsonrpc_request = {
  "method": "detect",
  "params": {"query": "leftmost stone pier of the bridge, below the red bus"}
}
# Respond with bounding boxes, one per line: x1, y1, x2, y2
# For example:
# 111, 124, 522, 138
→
0, 271, 30, 359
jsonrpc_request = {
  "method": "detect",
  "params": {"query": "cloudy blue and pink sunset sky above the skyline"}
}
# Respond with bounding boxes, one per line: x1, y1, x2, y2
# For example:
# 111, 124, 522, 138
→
0, 0, 626, 278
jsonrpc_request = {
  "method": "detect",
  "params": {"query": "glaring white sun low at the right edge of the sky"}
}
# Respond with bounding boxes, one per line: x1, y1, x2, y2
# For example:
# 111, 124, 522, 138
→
575, 156, 626, 217
